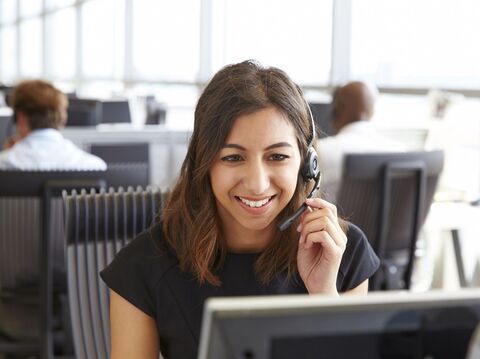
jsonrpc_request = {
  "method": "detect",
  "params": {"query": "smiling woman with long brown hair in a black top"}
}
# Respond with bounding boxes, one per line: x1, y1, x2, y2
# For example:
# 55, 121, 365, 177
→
101, 61, 379, 359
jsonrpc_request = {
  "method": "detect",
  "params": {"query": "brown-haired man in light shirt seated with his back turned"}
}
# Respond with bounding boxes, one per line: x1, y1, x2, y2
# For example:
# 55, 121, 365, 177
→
0, 80, 107, 170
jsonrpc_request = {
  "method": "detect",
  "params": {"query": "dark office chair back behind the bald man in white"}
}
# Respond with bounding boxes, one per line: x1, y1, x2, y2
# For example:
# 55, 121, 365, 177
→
337, 151, 444, 290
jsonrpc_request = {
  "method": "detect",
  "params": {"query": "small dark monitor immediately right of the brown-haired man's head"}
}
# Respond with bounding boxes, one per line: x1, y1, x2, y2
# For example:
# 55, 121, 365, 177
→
67, 96, 102, 127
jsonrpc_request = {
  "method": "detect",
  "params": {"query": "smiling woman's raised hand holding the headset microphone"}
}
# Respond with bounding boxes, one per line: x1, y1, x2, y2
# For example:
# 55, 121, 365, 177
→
297, 198, 347, 294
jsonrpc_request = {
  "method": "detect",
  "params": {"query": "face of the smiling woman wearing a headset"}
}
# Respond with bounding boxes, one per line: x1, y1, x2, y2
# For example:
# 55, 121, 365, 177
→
210, 107, 300, 240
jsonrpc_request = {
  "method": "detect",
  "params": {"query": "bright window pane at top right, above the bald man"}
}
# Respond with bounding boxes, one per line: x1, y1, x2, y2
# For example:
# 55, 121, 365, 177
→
351, 0, 480, 88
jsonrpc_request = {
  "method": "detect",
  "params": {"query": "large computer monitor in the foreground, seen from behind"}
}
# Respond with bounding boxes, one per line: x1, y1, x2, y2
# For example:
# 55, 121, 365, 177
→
198, 289, 480, 359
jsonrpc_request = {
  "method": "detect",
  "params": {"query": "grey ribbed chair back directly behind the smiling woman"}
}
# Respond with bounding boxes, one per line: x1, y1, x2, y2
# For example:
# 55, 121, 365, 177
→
64, 188, 163, 359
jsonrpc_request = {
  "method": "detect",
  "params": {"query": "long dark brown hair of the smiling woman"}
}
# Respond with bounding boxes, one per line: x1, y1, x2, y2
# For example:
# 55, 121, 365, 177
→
162, 60, 322, 285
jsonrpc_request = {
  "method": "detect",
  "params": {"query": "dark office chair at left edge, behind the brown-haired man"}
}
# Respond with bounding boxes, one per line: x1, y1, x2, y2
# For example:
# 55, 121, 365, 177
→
0, 165, 148, 359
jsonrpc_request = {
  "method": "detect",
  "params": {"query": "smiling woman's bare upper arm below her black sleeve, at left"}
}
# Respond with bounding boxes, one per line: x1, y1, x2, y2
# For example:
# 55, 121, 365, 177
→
110, 290, 160, 359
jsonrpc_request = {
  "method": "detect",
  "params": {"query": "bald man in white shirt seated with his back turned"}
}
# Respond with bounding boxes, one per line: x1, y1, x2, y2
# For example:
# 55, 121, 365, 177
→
318, 82, 405, 203
